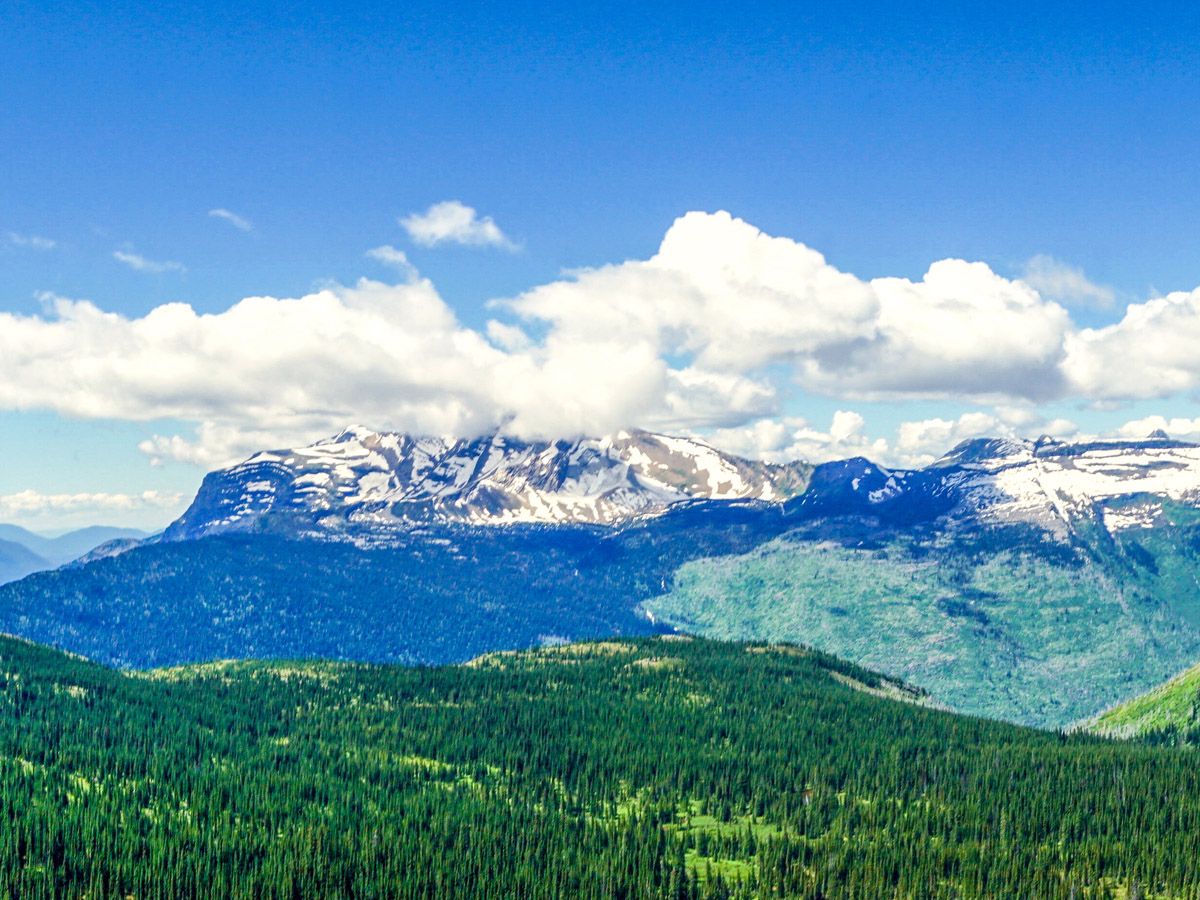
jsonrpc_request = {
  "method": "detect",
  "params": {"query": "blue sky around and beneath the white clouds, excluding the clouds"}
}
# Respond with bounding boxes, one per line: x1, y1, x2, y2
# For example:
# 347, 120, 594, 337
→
0, 0, 1200, 528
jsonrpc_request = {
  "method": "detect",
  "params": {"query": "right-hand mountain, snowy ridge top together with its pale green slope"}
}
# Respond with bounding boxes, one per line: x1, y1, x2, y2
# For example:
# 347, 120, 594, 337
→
643, 437, 1200, 726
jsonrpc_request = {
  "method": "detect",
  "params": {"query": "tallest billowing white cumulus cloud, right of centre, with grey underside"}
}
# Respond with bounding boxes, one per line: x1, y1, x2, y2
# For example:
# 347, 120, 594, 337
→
512, 212, 1070, 398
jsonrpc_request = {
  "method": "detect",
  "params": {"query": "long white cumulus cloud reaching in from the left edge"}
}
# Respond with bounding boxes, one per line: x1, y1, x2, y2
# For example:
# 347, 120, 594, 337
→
0, 281, 505, 441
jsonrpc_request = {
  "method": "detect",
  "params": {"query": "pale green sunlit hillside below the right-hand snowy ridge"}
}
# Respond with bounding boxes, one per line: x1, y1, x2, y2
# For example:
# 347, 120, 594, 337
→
643, 511, 1200, 727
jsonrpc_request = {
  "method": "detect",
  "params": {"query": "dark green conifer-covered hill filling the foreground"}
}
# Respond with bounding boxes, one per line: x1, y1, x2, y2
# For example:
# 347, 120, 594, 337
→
0, 638, 1200, 898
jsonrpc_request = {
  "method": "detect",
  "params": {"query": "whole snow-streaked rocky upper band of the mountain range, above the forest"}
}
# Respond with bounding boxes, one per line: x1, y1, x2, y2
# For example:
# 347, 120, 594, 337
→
164, 428, 1200, 546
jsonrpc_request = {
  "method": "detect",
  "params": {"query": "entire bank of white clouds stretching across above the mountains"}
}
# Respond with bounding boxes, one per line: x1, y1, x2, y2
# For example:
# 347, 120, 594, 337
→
0, 210, 1200, 467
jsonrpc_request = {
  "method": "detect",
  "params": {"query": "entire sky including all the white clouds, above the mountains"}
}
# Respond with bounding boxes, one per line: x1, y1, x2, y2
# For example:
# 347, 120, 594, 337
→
0, 0, 1200, 530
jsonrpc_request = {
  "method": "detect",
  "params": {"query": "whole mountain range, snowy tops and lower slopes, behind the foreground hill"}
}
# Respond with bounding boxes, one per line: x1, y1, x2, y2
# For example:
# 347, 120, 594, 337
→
0, 430, 1200, 726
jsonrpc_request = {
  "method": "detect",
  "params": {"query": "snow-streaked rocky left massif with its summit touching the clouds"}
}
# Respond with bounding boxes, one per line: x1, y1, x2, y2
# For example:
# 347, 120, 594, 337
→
164, 427, 811, 544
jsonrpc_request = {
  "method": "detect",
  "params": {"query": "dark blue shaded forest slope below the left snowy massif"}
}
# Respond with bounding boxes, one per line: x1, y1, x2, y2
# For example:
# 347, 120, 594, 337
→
0, 503, 787, 667
